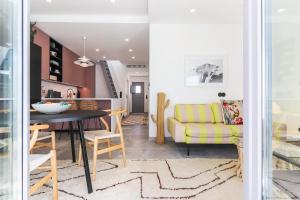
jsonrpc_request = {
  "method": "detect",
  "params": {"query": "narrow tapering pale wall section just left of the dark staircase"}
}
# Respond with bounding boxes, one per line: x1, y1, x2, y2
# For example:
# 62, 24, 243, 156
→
95, 63, 111, 98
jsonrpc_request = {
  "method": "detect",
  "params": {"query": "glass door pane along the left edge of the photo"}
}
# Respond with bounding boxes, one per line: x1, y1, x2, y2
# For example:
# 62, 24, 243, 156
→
0, 0, 22, 200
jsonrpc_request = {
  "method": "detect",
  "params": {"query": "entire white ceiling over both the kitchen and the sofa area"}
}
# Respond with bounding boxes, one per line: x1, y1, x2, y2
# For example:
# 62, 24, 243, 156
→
30, 0, 243, 65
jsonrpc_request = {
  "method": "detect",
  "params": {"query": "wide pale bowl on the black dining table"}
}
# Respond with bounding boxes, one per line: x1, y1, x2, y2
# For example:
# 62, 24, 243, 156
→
31, 102, 71, 114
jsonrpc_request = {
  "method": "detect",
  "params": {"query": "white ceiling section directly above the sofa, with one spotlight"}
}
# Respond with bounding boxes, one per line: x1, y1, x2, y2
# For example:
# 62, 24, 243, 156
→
148, 0, 243, 24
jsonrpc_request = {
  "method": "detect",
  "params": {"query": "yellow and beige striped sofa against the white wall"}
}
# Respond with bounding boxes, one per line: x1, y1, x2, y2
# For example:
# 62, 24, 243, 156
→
168, 103, 243, 144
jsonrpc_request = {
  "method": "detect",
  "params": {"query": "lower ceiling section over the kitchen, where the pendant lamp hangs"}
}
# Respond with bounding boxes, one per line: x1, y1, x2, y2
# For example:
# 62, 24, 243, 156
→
37, 22, 149, 65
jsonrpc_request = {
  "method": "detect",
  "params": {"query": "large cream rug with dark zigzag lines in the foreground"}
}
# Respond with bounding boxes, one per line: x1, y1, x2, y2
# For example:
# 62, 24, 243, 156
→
31, 159, 243, 200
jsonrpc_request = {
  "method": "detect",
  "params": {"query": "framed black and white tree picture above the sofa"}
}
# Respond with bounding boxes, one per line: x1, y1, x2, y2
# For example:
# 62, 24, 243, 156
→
185, 56, 226, 86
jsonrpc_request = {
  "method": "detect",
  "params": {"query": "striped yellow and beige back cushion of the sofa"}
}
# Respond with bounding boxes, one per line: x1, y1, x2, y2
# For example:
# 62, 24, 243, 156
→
175, 104, 215, 123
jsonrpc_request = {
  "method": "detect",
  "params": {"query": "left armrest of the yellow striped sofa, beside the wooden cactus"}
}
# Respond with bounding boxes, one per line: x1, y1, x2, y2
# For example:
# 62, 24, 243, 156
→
168, 117, 186, 142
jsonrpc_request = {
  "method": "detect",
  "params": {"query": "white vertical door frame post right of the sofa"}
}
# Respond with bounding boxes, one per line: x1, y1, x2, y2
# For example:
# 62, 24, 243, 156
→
243, 0, 267, 200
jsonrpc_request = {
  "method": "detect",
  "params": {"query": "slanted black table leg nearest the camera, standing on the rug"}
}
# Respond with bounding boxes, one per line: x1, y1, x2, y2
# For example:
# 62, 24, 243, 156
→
77, 121, 93, 193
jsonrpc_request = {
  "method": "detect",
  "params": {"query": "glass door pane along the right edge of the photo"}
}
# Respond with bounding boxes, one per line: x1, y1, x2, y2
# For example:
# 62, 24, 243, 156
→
264, 0, 300, 199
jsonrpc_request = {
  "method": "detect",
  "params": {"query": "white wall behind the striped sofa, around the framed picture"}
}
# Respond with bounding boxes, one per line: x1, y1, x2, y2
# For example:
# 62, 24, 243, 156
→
149, 24, 243, 137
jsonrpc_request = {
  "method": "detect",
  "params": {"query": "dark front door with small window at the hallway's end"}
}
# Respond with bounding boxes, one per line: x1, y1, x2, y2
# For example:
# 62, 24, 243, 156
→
131, 82, 145, 113
